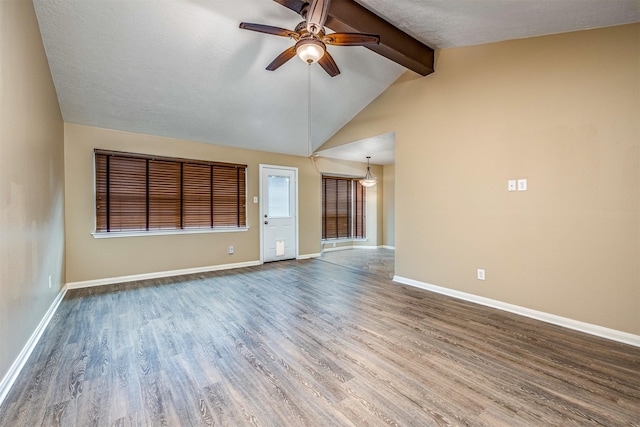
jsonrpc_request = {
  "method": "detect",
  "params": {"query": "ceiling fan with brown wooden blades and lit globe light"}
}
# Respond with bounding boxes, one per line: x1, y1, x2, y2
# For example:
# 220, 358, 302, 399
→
240, 0, 380, 77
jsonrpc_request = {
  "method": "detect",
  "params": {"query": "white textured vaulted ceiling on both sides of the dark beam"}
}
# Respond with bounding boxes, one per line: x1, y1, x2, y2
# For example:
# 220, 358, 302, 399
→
34, 0, 640, 160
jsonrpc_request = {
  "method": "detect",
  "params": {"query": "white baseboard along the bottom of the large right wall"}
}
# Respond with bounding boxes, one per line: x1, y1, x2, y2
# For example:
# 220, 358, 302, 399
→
393, 276, 640, 347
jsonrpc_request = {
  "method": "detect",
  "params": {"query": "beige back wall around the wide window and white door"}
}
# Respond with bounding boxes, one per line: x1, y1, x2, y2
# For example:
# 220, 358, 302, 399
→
65, 124, 377, 282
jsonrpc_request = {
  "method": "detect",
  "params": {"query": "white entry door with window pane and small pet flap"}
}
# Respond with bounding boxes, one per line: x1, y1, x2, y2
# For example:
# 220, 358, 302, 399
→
260, 165, 298, 262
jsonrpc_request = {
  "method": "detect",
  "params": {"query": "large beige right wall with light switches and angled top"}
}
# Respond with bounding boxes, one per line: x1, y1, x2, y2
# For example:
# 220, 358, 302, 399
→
327, 24, 640, 334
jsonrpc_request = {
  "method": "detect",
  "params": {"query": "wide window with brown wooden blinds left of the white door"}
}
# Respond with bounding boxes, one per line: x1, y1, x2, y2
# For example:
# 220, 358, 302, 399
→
95, 149, 247, 233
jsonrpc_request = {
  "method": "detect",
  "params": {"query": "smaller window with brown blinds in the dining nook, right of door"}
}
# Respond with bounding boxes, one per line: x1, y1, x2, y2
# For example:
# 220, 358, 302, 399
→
322, 176, 367, 240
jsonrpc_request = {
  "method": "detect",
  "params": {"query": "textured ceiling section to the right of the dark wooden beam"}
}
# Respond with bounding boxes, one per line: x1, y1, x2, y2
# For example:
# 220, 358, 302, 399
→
361, 0, 640, 49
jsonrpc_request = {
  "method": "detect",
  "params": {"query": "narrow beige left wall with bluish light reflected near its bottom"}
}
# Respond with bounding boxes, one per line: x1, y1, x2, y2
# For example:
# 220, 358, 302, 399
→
0, 0, 64, 379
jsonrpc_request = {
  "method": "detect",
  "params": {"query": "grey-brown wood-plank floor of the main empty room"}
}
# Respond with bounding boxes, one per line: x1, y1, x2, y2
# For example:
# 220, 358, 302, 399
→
0, 260, 640, 426
